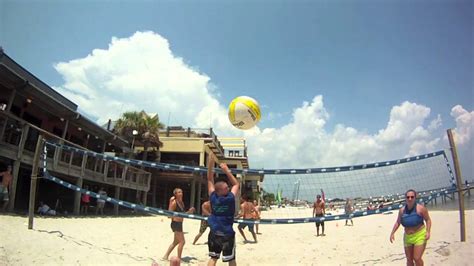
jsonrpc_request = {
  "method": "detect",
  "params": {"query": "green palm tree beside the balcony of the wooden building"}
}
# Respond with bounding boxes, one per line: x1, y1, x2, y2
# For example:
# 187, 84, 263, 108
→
114, 111, 164, 206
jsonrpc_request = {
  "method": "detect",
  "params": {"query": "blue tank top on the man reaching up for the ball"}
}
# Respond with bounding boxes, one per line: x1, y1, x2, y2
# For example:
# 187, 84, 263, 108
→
207, 192, 235, 236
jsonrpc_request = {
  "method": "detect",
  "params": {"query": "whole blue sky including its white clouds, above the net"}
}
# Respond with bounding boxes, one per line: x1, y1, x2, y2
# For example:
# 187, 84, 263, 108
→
0, 0, 474, 179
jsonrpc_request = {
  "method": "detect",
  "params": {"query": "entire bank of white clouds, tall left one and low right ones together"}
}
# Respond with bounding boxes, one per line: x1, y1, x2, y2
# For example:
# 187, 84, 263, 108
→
51, 32, 474, 179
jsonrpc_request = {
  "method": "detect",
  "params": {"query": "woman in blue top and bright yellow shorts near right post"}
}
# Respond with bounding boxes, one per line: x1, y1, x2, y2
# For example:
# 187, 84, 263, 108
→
390, 189, 431, 266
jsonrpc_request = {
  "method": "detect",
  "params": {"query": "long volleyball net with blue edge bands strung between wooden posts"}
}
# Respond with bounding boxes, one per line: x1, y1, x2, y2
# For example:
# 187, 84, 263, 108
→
42, 141, 456, 224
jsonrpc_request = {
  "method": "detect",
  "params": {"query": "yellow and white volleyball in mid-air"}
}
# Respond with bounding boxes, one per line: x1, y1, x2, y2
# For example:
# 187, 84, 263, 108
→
229, 96, 260, 130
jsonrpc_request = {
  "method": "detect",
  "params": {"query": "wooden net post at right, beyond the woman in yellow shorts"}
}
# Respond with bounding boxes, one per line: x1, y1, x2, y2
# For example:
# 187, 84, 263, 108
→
447, 129, 466, 242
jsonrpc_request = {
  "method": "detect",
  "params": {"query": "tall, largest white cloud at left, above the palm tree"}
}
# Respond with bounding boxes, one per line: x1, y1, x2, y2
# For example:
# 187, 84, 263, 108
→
55, 32, 230, 133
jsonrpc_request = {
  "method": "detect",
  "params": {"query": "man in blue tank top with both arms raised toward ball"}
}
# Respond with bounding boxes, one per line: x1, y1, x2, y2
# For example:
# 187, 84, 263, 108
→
207, 154, 240, 265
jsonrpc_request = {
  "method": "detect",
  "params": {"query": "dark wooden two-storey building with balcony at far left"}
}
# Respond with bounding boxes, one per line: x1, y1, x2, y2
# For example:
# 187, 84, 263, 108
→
0, 48, 151, 214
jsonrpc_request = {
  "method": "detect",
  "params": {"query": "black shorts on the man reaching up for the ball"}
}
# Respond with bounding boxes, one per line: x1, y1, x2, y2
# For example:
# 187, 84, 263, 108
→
207, 231, 235, 262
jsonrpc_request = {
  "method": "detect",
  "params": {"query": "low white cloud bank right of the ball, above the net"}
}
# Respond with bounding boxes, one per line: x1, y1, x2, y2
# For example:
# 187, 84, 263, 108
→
244, 96, 448, 167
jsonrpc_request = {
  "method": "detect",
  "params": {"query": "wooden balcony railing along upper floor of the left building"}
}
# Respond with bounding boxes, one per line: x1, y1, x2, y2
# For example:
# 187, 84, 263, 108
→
0, 110, 151, 191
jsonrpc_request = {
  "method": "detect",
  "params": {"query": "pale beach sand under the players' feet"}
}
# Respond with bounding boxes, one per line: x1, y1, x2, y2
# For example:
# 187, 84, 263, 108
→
0, 209, 474, 265
